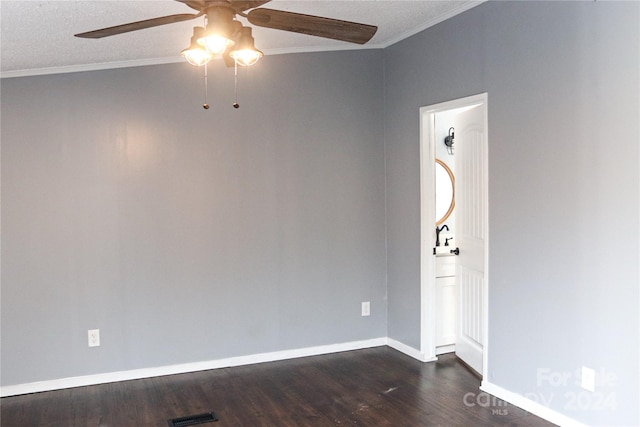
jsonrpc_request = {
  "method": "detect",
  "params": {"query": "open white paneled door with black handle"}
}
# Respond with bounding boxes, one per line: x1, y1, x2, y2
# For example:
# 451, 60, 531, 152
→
455, 104, 488, 375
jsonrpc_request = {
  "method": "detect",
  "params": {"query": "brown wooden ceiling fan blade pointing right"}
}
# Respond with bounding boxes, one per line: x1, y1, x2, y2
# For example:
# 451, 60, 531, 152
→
247, 9, 378, 44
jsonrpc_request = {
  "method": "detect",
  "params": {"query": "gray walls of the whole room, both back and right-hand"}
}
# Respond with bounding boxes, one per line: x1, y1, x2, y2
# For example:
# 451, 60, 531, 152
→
1, 2, 640, 425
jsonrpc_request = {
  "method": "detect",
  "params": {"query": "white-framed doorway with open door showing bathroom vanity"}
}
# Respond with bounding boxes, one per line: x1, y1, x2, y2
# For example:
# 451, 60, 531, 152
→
420, 93, 488, 375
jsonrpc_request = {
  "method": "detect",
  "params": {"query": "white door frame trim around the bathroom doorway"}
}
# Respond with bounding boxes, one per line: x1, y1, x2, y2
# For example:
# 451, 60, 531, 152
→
420, 92, 489, 376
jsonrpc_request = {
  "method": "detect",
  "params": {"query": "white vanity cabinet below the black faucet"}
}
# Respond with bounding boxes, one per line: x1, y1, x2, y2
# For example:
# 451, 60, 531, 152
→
436, 254, 457, 354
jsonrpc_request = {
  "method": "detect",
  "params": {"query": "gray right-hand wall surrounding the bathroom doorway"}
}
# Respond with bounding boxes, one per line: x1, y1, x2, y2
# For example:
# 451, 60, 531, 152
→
385, 2, 640, 425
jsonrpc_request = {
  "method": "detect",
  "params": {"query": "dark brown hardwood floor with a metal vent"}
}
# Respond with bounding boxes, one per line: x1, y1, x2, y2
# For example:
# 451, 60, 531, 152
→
0, 347, 553, 427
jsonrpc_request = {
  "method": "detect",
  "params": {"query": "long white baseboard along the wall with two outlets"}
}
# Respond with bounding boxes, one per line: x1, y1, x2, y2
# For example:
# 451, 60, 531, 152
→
0, 337, 387, 397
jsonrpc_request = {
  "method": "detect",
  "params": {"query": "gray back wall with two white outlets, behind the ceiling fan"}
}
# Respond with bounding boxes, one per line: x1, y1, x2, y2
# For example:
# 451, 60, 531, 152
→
1, 50, 387, 385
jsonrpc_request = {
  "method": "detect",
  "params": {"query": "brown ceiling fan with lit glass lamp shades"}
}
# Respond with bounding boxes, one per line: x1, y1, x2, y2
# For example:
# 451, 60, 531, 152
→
75, 0, 378, 66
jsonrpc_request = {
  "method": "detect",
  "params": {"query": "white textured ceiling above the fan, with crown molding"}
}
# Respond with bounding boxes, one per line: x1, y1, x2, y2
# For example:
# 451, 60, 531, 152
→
0, 0, 481, 77
